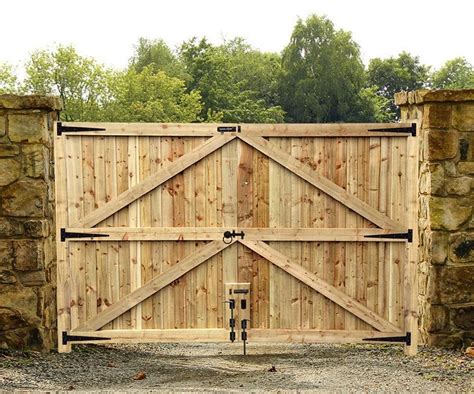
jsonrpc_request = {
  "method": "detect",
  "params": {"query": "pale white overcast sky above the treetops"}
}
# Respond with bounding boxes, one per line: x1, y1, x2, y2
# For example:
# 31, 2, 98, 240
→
0, 0, 474, 71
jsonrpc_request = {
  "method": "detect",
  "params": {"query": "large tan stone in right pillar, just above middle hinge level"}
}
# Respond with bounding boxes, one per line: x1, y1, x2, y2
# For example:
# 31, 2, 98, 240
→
430, 197, 472, 231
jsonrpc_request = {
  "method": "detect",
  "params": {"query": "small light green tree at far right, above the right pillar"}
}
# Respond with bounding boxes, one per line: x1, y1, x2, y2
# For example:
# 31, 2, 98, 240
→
431, 57, 474, 89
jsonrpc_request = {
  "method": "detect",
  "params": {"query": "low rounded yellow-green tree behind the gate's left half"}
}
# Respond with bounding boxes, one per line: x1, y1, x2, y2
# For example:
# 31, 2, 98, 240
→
103, 66, 202, 122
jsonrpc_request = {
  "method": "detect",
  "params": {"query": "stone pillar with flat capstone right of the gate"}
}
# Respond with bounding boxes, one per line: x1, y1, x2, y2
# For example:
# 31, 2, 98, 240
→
395, 90, 474, 346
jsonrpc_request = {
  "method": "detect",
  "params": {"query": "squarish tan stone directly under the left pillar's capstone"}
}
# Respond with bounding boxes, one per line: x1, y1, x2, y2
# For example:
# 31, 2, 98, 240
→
8, 112, 48, 143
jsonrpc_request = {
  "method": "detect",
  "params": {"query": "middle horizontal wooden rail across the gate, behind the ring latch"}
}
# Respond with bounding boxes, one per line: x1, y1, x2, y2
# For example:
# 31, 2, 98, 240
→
61, 227, 405, 242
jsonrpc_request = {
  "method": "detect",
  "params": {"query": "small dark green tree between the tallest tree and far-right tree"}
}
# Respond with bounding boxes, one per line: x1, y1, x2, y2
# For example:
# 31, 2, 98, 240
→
367, 52, 430, 119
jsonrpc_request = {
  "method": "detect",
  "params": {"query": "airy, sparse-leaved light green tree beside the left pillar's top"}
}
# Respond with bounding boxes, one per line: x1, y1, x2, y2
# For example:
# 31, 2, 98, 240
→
24, 46, 113, 121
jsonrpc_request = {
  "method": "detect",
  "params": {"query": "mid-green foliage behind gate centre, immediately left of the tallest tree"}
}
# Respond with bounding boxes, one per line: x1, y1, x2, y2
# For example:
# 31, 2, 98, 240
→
180, 38, 284, 123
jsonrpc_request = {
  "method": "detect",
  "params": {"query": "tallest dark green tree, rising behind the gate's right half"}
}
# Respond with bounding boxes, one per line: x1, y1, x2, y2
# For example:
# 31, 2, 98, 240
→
281, 15, 364, 122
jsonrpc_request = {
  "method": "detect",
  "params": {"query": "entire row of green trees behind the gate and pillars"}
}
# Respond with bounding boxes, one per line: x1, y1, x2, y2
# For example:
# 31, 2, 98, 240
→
0, 15, 474, 123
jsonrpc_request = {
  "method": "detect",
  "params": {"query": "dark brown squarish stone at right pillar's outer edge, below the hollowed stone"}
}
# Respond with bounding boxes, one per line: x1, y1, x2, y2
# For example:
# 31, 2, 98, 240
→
437, 265, 474, 304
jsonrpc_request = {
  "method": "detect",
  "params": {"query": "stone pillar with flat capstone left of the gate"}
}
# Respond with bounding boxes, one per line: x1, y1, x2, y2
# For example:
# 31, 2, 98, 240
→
0, 95, 61, 350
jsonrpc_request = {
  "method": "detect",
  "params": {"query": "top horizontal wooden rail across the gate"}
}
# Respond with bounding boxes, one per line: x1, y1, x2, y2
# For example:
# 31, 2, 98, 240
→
55, 122, 411, 137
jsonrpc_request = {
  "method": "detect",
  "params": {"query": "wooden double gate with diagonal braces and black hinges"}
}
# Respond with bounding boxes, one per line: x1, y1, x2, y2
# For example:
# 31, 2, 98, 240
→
55, 123, 417, 353
